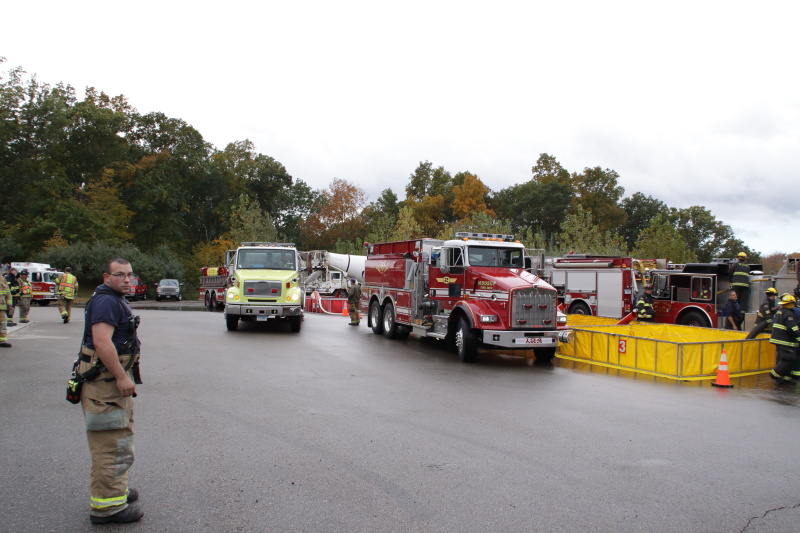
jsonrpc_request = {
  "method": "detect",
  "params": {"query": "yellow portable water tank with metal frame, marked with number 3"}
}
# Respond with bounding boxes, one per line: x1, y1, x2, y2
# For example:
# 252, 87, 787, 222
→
559, 315, 775, 380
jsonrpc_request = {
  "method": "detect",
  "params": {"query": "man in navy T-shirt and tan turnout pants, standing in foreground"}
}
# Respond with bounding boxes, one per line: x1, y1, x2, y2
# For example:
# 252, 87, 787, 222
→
79, 258, 144, 524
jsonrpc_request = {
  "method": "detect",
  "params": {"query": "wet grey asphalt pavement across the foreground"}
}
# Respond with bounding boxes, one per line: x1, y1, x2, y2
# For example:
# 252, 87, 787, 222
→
0, 302, 800, 533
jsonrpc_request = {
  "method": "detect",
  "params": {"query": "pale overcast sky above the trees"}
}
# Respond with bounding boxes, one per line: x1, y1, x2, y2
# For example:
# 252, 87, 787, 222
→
0, 0, 800, 254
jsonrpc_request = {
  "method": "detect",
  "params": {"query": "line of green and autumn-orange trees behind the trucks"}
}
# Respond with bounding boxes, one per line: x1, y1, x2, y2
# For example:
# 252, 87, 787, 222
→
0, 58, 757, 288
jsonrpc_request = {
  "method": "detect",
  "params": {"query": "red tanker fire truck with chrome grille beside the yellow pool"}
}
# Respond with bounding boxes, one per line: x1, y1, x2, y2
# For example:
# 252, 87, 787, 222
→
361, 233, 571, 362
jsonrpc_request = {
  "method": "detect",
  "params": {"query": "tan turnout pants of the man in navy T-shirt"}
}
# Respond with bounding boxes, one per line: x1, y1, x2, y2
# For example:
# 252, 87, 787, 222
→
79, 355, 134, 516
